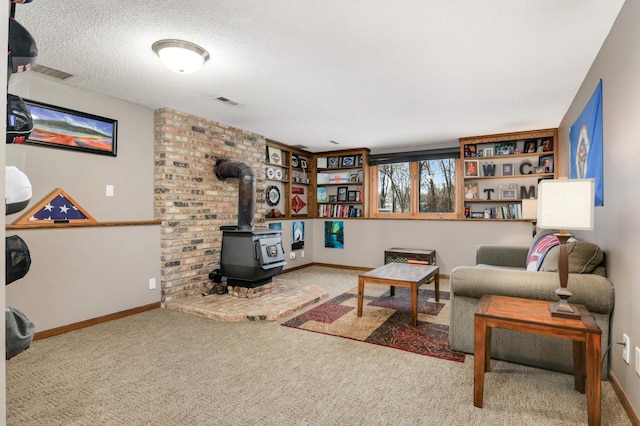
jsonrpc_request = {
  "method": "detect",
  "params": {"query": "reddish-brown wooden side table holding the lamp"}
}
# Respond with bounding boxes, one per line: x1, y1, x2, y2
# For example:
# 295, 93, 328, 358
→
473, 295, 602, 425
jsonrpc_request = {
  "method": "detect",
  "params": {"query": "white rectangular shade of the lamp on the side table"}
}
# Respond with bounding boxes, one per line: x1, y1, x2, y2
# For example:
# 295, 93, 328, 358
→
538, 179, 595, 230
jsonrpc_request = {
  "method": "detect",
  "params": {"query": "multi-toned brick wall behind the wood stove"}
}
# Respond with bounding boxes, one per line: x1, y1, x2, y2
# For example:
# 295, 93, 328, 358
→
154, 109, 266, 302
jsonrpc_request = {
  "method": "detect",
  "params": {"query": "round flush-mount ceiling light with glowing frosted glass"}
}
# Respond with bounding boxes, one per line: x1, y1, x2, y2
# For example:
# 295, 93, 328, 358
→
151, 39, 209, 74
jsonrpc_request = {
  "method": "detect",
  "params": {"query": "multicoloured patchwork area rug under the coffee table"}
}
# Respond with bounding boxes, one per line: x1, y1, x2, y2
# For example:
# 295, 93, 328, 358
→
282, 286, 465, 362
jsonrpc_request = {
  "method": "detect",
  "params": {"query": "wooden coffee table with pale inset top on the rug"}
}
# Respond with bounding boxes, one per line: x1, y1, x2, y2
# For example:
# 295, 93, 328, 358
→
358, 263, 440, 327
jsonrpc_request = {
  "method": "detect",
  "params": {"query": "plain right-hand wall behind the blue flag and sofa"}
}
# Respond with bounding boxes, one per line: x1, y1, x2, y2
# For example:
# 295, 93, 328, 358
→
559, 1, 640, 413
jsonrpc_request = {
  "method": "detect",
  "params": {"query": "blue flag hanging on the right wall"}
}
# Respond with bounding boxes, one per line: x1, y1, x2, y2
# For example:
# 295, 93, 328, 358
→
569, 80, 604, 206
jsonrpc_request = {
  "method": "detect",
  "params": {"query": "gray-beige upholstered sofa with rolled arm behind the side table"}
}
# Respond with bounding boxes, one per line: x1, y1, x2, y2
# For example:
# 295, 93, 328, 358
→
449, 242, 614, 379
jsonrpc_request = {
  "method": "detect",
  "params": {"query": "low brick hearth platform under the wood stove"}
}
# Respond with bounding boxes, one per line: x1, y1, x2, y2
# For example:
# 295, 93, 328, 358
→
164, 277, 328, 322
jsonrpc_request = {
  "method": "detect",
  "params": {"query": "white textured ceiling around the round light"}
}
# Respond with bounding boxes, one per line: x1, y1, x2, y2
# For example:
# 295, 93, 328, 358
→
8, 0, 624, 152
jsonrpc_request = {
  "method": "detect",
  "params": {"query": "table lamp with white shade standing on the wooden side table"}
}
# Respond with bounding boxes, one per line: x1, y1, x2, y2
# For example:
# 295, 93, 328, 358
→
538, 178, 595, 318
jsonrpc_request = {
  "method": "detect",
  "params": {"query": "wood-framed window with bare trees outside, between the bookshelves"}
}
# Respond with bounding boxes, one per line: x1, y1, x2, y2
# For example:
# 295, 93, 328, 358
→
370, 148, 460, 219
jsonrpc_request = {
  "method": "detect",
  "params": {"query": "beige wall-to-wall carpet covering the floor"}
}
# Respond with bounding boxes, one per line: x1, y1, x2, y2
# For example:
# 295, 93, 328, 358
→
6, 267, 631, 426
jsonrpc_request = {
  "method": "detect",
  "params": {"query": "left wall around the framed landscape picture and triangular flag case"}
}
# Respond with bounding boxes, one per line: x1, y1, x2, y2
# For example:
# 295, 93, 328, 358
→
5, 73, 160, 332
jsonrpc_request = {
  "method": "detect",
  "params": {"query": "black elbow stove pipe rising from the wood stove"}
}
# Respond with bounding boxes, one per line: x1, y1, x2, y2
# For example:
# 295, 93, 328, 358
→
214, 160, 256, 231
